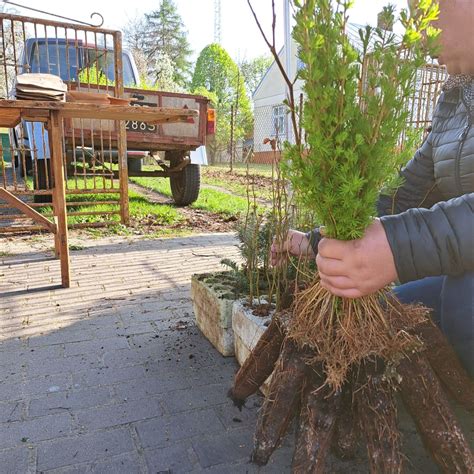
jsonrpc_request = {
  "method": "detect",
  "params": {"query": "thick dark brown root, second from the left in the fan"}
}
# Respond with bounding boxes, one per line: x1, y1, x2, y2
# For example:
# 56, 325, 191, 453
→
252, 339, 307, 465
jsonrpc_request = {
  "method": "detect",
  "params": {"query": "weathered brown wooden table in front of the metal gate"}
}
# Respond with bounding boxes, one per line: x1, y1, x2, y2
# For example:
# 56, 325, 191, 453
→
0, 100, 198, 288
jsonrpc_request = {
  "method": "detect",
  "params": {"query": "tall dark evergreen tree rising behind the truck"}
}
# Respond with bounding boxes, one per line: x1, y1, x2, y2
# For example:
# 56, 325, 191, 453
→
144, 0, 192, 86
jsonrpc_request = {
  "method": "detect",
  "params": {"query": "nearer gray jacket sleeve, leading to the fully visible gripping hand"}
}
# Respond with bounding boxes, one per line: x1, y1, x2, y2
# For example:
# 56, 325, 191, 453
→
381, 193, 474, 283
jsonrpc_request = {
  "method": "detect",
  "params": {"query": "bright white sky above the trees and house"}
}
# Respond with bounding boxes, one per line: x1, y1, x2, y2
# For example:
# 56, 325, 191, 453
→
1, 0, 406, 62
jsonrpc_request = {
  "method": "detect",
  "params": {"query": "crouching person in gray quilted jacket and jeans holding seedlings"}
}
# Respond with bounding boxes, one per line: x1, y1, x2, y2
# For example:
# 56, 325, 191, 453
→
271, 0, 474, 375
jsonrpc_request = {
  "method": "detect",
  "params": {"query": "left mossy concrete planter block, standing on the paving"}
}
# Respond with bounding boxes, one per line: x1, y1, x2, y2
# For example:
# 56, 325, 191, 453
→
191, 272, 236, 356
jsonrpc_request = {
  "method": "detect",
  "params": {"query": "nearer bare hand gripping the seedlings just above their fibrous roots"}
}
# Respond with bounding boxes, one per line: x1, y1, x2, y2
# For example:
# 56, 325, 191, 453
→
316, 219, 397, 298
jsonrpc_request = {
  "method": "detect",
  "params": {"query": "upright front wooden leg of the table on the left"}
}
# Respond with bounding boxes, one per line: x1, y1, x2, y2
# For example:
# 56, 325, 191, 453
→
48, 111, 71, 288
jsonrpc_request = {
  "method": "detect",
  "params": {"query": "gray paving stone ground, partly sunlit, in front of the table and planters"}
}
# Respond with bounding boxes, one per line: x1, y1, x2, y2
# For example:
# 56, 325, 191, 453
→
0, 234, 472, 474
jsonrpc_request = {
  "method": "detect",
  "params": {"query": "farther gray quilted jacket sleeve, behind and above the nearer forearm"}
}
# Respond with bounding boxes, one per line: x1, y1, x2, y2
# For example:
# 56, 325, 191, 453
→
377, 133, 442, 216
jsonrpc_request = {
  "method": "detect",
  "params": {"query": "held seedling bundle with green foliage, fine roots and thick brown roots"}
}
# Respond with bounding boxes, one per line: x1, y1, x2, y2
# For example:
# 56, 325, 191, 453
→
230, 0, 474, 473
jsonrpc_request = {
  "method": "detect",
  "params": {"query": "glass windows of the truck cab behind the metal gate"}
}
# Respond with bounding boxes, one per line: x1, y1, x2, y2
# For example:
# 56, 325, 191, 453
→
27, 39, 136, 86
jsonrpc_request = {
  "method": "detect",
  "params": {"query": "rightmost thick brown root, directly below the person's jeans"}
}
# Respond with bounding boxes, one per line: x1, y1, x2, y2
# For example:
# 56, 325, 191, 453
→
414, 320, 474, 411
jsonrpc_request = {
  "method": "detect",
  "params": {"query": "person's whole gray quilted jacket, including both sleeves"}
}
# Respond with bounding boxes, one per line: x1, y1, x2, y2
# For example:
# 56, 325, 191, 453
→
310, 80, 474, 283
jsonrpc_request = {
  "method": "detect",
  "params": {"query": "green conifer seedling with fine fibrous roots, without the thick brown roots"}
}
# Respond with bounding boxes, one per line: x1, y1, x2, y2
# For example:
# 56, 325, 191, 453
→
285, 0, 439, 389
